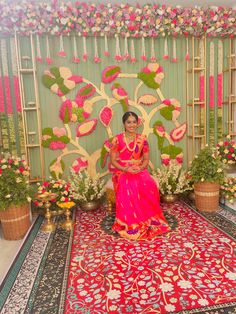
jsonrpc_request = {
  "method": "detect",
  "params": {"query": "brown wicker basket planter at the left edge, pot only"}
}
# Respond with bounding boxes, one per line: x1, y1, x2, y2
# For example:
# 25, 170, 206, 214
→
0, 203, 30, 240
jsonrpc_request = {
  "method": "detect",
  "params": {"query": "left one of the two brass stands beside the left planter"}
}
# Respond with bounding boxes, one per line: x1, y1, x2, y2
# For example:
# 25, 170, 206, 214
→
37, 192, 57, 232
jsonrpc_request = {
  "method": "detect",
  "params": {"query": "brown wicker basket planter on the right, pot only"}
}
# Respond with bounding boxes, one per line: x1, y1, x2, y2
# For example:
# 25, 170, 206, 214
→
194, 182, 220, 212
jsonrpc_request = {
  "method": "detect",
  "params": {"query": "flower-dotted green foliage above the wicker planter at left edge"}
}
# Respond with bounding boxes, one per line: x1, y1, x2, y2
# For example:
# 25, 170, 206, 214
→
0, 157, 32, 211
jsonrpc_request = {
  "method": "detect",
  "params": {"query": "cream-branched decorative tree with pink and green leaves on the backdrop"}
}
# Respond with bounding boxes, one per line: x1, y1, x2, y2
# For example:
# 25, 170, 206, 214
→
42, 63, 187, 178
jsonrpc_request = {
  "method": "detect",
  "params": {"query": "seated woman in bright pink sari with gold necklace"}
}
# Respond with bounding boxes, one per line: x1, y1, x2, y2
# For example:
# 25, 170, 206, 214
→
110, 111, 170, 240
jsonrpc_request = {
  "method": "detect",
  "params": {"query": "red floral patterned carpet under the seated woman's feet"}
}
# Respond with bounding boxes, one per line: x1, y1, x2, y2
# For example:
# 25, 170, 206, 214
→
65, 202, 236, 314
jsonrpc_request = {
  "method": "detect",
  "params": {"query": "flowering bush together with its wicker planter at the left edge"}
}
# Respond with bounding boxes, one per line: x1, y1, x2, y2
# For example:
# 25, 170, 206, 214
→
0, 156, 32, 240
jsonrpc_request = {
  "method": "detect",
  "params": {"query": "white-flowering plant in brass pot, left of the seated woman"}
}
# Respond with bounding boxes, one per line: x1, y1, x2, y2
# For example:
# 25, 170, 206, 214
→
70, 169, 105, 211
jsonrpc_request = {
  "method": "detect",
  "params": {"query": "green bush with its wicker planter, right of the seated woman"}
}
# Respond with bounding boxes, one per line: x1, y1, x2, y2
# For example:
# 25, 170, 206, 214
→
190, 145, 224, 212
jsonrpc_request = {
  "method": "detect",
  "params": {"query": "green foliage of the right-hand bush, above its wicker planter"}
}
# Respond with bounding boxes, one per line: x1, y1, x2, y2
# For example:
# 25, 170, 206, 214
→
190, 146, 224, 183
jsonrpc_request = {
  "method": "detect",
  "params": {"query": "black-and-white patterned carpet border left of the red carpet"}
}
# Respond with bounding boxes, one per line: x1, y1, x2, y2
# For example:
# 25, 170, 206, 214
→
0, 216, 73, 314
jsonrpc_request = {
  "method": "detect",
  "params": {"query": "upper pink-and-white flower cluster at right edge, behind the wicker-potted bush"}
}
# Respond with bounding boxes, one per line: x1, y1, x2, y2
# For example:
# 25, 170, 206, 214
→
216, 135, 236, 170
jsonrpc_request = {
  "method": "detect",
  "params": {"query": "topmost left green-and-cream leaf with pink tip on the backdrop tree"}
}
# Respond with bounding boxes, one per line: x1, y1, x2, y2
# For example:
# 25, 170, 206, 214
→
42, 67, 83, 96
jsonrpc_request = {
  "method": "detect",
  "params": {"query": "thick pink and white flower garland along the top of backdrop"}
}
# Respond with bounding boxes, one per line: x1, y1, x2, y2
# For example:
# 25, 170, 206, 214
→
0, 0, 235, 38
